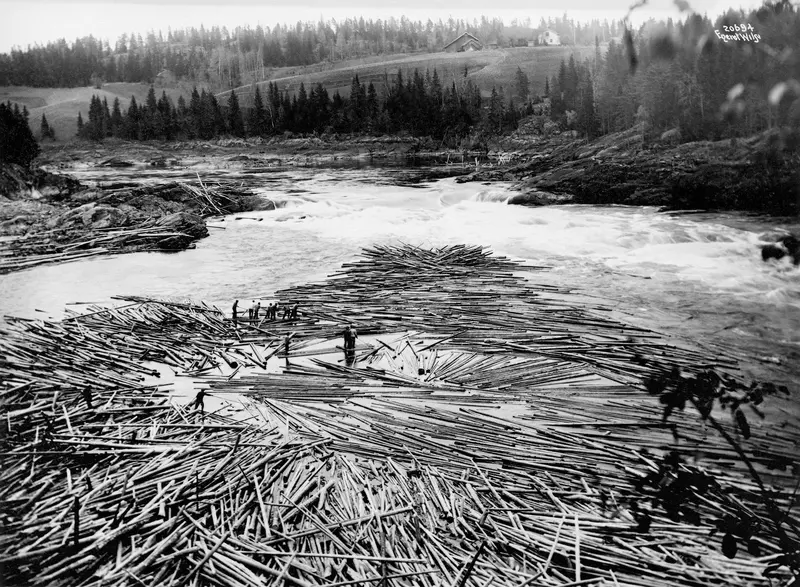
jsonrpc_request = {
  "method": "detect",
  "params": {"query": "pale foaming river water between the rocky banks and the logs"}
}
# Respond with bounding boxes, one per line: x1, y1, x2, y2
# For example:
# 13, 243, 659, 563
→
0, 167, 800, 387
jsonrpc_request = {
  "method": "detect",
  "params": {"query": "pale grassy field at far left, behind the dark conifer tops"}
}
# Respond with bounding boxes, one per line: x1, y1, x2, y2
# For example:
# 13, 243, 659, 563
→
0, 83, 191, 143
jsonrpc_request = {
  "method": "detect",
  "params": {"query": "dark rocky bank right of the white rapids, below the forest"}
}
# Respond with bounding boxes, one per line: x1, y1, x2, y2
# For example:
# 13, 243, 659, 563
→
472, 129, 800, 216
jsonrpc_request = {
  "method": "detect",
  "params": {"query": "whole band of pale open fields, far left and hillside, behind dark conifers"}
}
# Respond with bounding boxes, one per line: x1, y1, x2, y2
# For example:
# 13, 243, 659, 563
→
0, 47, 594, 143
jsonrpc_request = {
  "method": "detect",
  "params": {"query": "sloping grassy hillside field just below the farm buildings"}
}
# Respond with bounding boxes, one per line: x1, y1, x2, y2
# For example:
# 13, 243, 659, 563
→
228, 46, 594, 105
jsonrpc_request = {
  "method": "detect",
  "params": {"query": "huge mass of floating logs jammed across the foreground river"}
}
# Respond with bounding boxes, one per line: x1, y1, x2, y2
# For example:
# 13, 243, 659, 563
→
0, 246, 798, 587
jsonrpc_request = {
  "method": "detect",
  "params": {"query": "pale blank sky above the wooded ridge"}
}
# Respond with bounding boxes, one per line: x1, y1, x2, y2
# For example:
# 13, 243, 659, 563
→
0, 0, 761, 52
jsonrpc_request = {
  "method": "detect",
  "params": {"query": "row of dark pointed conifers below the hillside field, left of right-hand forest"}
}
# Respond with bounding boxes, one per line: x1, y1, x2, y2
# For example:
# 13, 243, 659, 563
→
77, 69, 521, 144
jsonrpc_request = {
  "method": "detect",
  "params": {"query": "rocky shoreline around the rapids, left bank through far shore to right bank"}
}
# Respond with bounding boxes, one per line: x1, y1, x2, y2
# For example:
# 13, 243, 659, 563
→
0, 129, 800, 272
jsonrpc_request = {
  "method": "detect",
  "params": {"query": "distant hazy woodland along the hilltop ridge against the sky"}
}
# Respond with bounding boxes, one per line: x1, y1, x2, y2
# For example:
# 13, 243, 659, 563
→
0, 14, 621, 89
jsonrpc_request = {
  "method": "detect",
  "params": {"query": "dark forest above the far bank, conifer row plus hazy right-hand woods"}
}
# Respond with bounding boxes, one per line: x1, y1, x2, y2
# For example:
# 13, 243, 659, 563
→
64, 0, 800, 152
